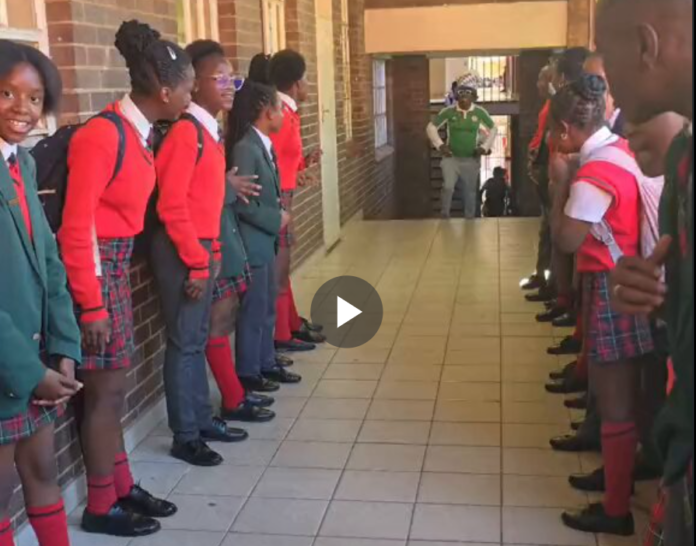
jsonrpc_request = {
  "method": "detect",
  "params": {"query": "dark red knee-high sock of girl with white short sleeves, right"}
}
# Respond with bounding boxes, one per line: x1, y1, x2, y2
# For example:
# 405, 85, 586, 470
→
602, 423, 638, 517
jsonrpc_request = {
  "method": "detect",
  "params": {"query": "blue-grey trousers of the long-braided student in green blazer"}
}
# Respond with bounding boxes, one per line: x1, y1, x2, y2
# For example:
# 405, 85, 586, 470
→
235, 263, 277, 377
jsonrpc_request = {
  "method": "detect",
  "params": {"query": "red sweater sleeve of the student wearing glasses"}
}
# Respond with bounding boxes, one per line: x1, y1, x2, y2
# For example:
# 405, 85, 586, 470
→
155, 122, 210, 279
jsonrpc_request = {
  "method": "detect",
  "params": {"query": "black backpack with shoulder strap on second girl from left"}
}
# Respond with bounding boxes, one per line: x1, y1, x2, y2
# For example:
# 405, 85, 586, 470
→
31, 111, 126, 233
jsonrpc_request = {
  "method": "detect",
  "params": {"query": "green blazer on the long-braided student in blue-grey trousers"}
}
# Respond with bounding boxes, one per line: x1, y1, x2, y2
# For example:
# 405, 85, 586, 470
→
233, 127, 281, 267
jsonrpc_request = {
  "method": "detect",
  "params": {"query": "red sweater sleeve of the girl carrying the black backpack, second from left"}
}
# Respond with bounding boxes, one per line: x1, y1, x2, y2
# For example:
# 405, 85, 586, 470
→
58, 119, 119, 322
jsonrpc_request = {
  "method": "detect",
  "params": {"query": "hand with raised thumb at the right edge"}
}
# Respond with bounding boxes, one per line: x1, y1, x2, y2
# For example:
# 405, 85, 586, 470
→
610, 236, 672, 315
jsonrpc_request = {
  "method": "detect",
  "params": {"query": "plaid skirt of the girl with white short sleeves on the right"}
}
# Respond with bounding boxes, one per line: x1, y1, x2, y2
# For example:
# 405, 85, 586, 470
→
582, 272, 654, 364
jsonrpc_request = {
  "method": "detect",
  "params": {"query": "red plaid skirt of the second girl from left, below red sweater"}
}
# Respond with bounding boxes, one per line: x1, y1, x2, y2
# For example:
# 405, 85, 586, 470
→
80, 238, 135, 370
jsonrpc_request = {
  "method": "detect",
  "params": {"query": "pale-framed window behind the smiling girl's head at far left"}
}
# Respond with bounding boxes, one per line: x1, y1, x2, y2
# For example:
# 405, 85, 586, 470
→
0, 0, 56, 136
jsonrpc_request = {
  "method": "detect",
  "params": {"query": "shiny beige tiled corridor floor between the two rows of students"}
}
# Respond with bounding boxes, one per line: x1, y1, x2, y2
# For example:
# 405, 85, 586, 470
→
28, 220, 650, 546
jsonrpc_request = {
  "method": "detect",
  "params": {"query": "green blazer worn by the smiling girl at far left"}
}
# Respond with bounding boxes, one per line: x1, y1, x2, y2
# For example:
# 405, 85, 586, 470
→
0, 149, 82, 419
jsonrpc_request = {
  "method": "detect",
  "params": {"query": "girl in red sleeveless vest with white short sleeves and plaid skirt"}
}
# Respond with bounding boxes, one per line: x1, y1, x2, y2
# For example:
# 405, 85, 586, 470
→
551, 74, 653, 536
